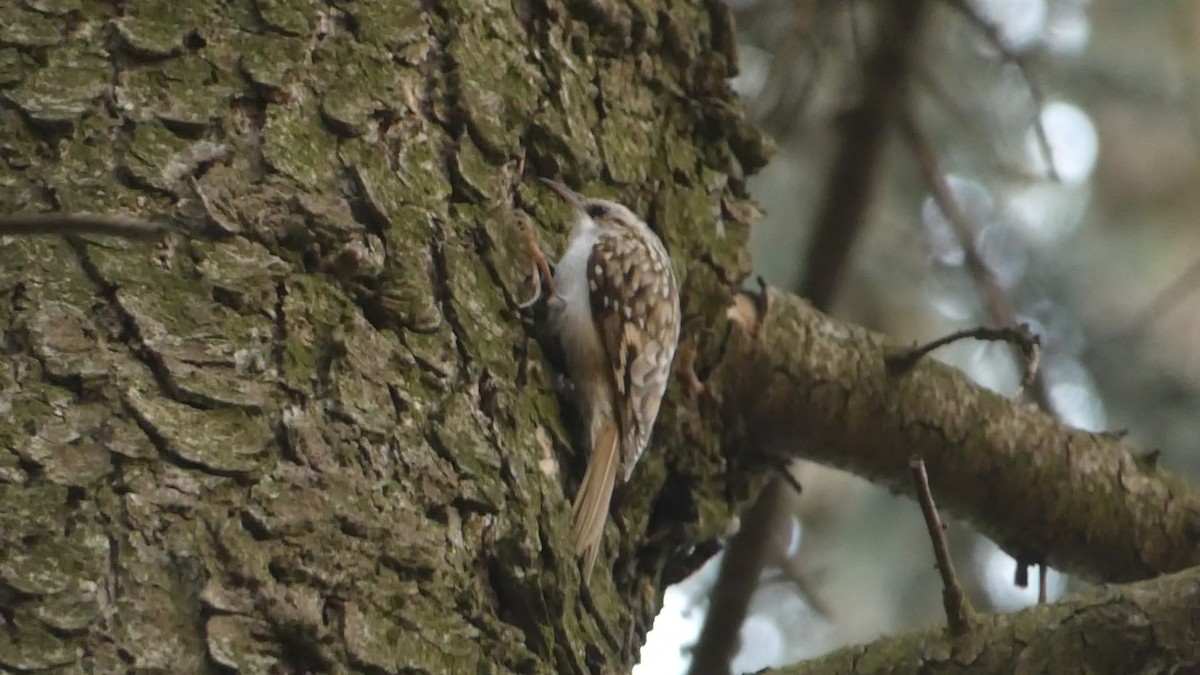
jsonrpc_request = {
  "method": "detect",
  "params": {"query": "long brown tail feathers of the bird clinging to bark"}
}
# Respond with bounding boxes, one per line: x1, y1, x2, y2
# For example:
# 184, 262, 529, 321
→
571, 422, 620, 584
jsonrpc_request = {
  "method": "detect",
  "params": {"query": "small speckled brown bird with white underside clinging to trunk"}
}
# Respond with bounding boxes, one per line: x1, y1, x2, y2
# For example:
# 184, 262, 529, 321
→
540, 179, 680, 584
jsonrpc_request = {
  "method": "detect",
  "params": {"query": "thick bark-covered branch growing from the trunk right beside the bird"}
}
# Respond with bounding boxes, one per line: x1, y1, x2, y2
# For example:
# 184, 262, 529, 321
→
707, 289, 1200, 581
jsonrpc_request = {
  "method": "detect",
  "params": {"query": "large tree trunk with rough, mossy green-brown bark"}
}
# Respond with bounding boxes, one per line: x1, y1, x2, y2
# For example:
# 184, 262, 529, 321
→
0, 0, 766, 673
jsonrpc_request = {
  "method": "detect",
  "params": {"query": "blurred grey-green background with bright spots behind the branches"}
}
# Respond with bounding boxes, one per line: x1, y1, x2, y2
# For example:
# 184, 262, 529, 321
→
634, 0, 1200, 675
